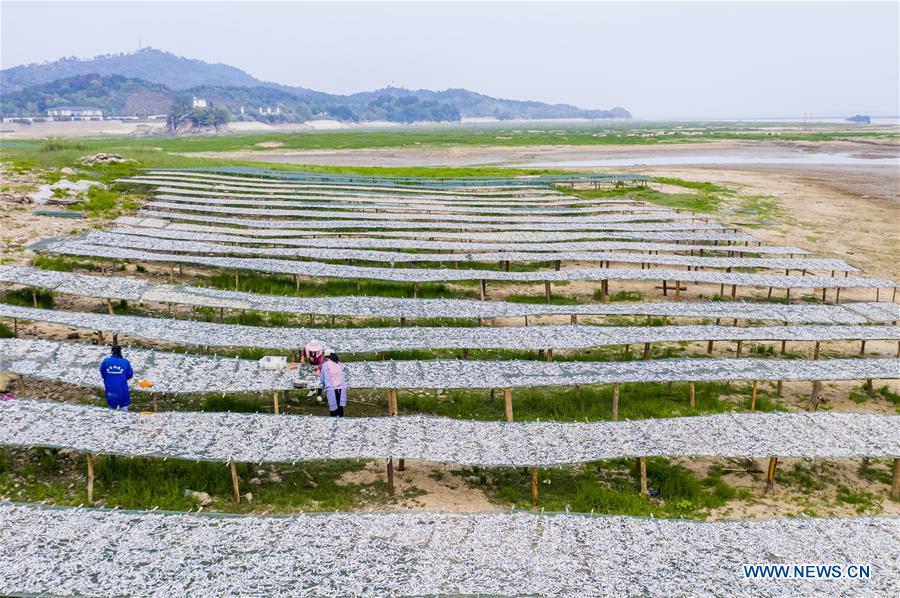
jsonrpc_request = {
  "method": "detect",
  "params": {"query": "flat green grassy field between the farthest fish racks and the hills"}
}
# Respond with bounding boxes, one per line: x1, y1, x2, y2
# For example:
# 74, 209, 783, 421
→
0, 123, 898, 176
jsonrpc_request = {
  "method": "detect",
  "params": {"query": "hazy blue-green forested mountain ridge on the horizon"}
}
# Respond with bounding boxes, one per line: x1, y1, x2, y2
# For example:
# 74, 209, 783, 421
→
0, 48, 631, 122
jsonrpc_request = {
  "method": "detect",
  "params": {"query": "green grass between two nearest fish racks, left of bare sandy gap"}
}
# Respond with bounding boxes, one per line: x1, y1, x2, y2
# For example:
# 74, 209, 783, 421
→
0, 448, 391, 513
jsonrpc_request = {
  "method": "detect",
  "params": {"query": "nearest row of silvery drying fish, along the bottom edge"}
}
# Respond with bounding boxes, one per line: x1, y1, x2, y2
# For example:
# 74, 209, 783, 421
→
0, 503, 900, 597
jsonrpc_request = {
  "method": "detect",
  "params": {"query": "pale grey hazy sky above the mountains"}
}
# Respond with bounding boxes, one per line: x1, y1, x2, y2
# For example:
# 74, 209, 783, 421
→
0, 1, 900, 118
